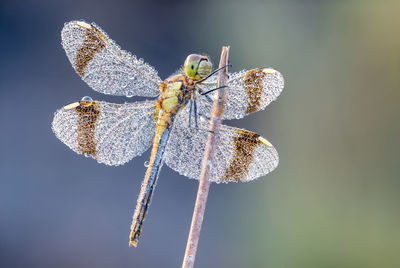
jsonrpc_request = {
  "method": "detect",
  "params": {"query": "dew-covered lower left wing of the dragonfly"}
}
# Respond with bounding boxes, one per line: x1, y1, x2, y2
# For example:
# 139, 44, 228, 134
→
52, 101, 155, 166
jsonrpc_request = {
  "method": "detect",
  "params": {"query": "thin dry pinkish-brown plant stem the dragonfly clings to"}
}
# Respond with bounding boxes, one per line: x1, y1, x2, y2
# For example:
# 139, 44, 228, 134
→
182, 46, 229, 268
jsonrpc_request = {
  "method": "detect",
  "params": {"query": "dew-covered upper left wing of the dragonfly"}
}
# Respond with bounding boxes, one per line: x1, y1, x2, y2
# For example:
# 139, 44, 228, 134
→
61, 21, 162, 97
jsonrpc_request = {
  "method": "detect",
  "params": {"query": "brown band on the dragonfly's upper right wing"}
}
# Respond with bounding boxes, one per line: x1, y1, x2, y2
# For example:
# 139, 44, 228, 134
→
244, 68, 266, 114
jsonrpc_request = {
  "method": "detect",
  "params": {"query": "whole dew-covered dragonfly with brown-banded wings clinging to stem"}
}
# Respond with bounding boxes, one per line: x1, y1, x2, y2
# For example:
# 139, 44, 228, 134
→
52, 21, 284, 247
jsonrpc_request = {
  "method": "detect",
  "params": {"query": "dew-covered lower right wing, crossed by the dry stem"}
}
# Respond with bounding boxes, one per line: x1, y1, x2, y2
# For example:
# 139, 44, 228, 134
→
164, 110, 279, 183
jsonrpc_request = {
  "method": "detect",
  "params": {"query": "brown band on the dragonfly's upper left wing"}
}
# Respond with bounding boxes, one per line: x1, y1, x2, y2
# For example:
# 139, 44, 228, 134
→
75, 25, 107, 77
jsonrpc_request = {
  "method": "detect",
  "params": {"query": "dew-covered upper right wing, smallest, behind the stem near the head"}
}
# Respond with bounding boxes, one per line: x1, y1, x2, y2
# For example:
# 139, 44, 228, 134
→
197, 68, 284, 119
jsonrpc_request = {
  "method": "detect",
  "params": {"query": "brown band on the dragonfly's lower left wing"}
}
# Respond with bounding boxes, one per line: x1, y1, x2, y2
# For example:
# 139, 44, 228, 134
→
75, 101, 100, 158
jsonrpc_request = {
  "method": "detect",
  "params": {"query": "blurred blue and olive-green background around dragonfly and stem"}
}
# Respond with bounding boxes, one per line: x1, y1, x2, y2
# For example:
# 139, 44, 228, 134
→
0, 0, 400, 268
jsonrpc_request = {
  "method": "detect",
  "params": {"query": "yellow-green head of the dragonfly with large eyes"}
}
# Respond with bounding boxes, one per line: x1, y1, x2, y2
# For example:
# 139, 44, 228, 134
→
183, 54, 212, 81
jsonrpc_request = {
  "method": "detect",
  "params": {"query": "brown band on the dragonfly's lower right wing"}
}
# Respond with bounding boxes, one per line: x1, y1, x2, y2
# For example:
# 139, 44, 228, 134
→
222, 130, 260, 181
